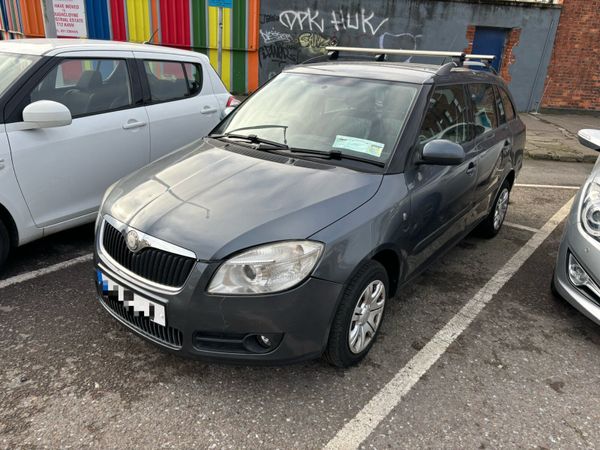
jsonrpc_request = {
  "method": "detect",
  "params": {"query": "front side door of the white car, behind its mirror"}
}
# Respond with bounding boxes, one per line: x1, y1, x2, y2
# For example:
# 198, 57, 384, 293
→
6, 51, 150, 227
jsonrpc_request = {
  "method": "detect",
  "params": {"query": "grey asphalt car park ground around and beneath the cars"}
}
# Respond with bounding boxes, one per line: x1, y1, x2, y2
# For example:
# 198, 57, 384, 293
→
0, 160, 600, 449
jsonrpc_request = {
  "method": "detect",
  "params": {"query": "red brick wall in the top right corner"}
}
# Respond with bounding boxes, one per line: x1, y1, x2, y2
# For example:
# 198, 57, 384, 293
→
542, 0, 600, 111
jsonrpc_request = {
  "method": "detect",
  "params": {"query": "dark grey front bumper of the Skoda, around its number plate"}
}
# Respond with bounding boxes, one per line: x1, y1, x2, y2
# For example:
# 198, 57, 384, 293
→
95, 254, 342, 364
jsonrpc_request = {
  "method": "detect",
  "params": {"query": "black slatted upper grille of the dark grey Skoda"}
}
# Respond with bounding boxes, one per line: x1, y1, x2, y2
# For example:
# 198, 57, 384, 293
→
102, 222, 195, 287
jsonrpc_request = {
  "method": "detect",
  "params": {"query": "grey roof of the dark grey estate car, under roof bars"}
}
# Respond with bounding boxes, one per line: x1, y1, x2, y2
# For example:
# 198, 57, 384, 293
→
284, 61, 499, 84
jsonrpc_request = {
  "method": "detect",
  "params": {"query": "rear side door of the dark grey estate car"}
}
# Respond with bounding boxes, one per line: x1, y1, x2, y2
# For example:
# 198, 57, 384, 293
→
468, 83, 512, 221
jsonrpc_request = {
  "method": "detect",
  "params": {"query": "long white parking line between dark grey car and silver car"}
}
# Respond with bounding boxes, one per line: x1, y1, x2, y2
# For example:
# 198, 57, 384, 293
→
325, 198, 573, 449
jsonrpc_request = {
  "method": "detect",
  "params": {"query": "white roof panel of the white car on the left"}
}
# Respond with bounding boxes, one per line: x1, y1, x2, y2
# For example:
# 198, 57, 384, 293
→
0, 39, 205, 57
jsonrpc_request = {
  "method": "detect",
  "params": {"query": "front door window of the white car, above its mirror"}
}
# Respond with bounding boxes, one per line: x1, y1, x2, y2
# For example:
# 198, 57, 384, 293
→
29, 59, 132, 118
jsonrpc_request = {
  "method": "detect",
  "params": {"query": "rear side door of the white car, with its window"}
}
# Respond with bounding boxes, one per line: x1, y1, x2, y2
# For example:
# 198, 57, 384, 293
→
135, 52, 221, 160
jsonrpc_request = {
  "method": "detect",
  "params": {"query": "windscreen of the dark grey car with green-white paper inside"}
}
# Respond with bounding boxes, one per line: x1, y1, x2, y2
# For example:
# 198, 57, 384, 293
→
215, 73, 419, 162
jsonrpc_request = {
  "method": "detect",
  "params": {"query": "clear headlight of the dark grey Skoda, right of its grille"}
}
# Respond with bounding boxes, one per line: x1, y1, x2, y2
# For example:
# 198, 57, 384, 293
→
208, 241, 324, 295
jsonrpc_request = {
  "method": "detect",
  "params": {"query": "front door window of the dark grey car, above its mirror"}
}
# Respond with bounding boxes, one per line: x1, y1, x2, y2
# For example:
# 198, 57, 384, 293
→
419, 85, 471, 145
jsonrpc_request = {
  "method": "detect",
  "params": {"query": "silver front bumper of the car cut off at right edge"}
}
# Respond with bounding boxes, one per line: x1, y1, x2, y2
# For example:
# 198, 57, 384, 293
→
553, 197, 600, 325
